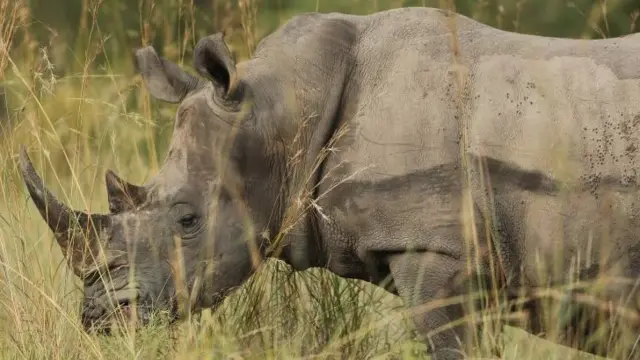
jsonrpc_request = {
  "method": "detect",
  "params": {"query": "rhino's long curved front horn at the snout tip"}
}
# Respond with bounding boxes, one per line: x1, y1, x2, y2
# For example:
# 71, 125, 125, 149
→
20, 146, 109, 277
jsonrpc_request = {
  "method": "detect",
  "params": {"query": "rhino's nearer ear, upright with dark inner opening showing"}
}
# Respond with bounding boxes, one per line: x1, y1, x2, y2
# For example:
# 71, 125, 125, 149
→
193, 31, 238, 98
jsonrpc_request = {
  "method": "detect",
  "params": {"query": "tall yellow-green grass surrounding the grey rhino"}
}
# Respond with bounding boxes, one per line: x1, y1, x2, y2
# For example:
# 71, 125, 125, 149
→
0, 0, 640, 359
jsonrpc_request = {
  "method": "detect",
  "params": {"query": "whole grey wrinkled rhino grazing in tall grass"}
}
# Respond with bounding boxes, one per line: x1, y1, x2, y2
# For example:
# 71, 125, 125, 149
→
22, 8, 640, 359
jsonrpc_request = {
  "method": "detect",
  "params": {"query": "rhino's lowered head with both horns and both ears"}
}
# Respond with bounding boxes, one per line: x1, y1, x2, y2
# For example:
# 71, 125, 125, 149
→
20, 33, 290, 331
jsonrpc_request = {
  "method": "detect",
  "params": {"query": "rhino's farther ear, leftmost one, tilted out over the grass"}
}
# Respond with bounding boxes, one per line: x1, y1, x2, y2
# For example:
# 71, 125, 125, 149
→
134, 46, 198, 103
